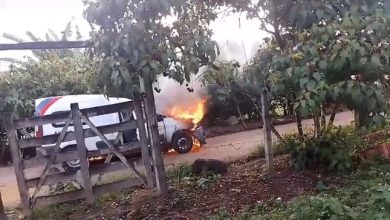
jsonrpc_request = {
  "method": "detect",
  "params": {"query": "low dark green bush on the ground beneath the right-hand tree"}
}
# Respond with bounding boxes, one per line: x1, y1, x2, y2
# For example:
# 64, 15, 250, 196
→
281, 127, 364, 172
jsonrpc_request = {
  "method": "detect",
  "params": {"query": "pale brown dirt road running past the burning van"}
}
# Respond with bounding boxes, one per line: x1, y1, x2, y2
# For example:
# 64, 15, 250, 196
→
0, 112, 353, 207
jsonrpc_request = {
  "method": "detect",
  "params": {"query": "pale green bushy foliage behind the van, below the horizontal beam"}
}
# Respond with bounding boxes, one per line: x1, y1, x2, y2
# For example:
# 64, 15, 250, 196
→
0, 53, 96, 117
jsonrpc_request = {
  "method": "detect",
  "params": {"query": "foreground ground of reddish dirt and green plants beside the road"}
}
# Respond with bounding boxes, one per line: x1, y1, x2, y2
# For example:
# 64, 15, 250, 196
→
11, 127, 384, 220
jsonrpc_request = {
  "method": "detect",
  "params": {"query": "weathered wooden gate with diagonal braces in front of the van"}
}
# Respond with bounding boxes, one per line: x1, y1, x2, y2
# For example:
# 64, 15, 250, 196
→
3, 96, 161, 215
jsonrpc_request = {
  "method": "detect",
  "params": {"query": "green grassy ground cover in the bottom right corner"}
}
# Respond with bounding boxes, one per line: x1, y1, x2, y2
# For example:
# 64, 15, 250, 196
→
210, 162, 390, 220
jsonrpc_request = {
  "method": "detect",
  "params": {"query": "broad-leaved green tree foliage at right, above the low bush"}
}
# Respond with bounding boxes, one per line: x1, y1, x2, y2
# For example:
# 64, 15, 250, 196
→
274, 7, 390, 132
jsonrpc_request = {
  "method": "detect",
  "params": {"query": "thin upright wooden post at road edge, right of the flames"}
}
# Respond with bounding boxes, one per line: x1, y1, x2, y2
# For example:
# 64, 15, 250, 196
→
261, 88, 273, 175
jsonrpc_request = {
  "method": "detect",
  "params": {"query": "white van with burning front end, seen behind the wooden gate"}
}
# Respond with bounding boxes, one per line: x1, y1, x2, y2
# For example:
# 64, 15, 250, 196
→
35, 95, 205, 169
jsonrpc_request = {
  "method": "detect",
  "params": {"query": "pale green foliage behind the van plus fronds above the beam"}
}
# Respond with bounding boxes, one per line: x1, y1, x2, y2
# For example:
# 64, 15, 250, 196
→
0, 23, 99, 117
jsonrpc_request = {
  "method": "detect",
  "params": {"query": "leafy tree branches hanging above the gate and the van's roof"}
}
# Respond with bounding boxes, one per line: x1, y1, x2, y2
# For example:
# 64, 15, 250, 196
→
85, 0, 219, 97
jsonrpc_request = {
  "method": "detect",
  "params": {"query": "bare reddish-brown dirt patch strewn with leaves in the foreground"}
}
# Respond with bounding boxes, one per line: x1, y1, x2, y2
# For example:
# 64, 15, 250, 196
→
64, 156, 341, 220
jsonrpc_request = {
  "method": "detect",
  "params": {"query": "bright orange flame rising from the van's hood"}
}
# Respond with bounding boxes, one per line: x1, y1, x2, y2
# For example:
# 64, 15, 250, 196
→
167, 99, 206, 125
